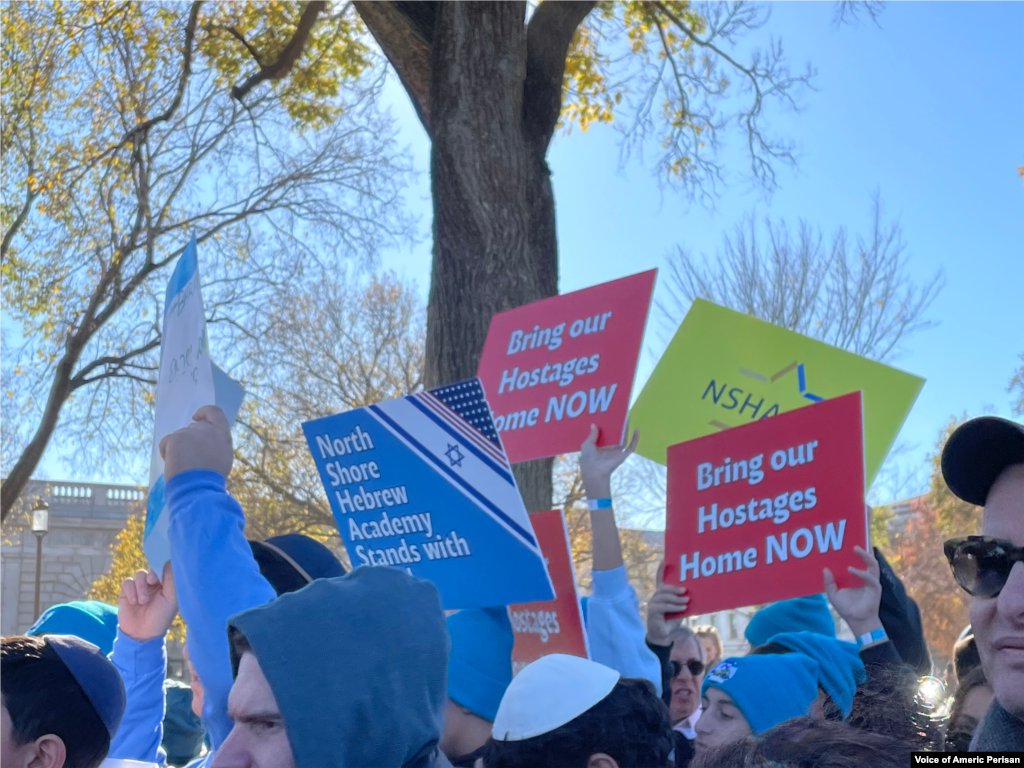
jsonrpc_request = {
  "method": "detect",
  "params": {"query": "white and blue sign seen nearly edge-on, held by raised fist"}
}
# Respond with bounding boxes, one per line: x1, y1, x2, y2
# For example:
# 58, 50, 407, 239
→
142, 237, 245, 573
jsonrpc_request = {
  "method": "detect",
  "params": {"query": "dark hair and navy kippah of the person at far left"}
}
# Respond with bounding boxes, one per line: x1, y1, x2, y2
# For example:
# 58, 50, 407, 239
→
0, 636, 111, 768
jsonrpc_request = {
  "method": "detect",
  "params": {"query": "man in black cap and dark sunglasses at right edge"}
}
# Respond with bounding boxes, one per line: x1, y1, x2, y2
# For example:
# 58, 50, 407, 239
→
942, 416, 1024, 752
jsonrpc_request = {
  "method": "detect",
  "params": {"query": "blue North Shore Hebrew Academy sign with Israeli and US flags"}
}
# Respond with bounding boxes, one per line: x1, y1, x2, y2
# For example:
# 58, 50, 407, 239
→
302, 379, 554, 609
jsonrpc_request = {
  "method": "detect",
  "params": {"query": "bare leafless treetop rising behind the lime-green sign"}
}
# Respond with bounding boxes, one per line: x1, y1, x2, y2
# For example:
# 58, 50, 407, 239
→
658, 197, 943, 361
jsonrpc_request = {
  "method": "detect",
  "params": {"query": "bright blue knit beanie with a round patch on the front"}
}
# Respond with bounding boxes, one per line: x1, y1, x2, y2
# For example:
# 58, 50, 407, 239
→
700, 653, 818, 734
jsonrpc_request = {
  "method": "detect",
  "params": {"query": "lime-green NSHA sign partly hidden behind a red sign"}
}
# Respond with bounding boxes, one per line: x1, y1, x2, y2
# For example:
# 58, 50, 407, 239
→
630, 299, 925, 486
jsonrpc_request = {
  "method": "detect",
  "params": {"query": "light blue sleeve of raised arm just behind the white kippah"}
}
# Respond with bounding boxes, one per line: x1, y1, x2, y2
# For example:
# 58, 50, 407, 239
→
587, 565, 662, 696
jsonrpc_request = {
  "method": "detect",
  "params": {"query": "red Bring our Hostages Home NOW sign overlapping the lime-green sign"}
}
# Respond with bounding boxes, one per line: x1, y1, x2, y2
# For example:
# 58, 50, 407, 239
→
665, 392, 868, 614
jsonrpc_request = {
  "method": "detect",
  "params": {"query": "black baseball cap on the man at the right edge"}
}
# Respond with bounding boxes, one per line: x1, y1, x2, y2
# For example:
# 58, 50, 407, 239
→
942, 416, 1024, 507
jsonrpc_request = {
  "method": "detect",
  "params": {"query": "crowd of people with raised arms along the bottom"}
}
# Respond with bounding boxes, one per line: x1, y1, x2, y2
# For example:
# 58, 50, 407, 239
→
0, 407, 1024, 768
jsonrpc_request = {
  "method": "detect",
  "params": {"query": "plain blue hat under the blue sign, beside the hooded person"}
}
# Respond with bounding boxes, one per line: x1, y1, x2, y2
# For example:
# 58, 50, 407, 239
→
447, 605, 512, 723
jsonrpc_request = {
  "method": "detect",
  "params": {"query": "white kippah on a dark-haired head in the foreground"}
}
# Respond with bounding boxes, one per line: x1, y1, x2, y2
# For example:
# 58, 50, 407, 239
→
490, 653, 620, 741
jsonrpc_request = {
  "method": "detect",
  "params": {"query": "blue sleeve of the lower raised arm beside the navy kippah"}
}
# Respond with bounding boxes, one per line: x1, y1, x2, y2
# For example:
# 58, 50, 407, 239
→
106, 629, 167, 765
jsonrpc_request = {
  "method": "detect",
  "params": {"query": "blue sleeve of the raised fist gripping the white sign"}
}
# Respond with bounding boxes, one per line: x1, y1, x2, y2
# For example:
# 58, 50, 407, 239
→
165, 469, 275, 750
